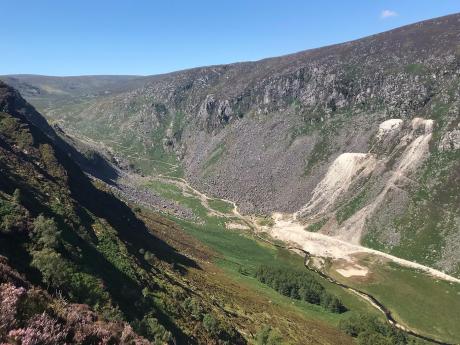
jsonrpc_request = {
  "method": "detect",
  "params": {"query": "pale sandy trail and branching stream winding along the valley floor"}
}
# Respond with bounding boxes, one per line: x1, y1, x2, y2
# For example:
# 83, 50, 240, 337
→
115, 171, 460, 345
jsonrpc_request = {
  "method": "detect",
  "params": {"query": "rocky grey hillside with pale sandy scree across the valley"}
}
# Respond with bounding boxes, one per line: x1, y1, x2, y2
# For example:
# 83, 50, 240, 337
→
1, 14, 460, 273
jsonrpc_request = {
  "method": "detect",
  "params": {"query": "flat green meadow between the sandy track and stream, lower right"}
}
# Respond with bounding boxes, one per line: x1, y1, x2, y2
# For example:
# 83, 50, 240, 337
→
332, 263, 460, 343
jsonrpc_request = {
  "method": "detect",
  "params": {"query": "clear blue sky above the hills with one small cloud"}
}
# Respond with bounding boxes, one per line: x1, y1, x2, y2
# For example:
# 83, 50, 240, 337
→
0, 0, 460, 75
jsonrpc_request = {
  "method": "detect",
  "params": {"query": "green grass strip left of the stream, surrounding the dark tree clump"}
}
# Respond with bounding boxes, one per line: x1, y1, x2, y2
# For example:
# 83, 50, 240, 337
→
148, 177, 382, 326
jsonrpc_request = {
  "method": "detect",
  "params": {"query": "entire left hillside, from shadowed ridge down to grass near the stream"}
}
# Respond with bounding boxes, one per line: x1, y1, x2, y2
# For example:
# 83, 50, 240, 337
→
0, 78, 384, 345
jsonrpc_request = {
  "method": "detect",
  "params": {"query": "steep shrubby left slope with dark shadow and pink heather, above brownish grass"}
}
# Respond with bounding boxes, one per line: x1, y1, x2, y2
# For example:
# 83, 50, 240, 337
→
0, 79, 252, 344
